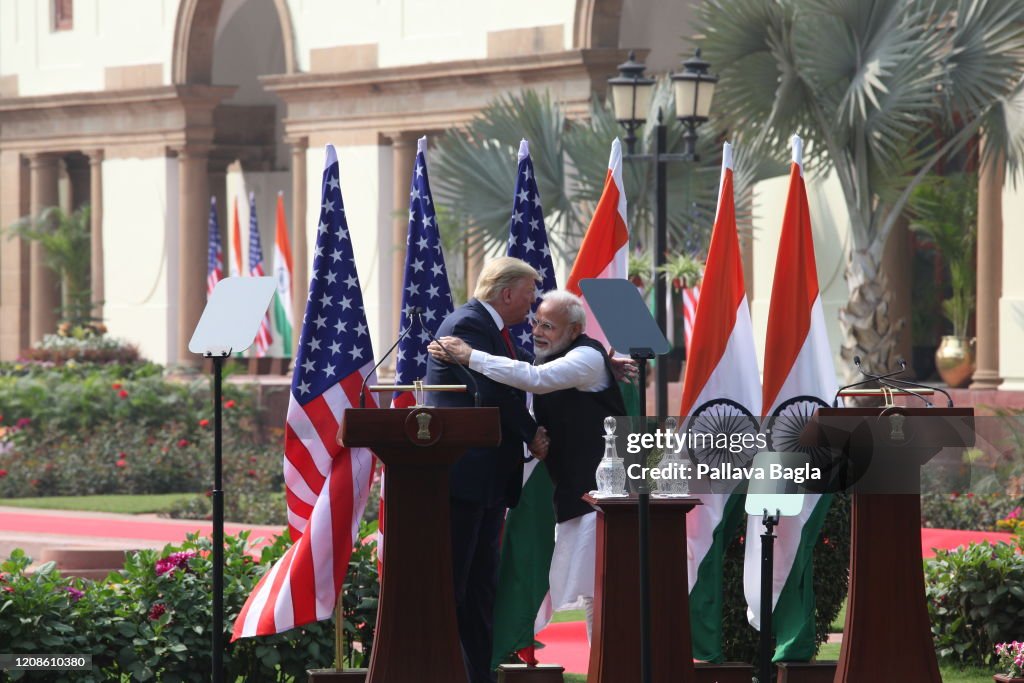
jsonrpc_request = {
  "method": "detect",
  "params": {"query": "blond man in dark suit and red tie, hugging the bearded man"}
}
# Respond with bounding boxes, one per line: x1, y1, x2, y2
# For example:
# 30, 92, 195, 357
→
426, 257, 548, 683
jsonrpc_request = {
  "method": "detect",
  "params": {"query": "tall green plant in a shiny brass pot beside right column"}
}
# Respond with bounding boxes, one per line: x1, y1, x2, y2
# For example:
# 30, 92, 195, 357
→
910, 173, 978, 387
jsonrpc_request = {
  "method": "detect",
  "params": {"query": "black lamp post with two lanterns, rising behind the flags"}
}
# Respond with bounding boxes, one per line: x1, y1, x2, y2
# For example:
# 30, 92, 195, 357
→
608, 48, 718, 417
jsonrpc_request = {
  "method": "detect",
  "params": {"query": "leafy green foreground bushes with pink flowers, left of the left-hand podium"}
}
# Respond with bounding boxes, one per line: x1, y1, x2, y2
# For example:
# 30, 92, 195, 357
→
0, 526, 378, 682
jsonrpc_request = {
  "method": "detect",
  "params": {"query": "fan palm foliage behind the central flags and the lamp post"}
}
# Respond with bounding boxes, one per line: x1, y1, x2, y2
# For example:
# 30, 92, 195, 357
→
431, 82, 764, 268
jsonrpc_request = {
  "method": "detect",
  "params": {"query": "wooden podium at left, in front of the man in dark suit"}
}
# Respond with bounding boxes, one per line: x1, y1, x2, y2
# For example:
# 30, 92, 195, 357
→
338, 407, 501, 683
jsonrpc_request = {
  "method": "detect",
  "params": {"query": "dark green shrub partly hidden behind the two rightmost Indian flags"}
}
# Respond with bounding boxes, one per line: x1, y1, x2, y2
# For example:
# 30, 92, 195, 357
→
722, 495, 850, 663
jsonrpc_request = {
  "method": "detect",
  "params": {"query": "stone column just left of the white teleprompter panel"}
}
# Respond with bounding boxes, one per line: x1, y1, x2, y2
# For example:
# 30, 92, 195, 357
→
175, 145, 210, 367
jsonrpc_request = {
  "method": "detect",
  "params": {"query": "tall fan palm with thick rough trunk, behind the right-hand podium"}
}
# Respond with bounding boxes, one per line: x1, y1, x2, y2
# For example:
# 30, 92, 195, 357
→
697, 0, 1024, 370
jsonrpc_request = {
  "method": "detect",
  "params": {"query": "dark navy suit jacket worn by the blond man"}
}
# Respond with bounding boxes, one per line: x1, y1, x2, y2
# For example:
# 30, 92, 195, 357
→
426, 299, 537, 508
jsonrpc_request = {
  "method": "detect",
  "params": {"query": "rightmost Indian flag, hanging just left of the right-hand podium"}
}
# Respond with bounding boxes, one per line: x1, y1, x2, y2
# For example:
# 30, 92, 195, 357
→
743, 135, 836, 661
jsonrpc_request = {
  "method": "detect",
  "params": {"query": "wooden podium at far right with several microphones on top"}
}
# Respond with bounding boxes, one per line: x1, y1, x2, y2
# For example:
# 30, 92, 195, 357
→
809, 407, 974, 683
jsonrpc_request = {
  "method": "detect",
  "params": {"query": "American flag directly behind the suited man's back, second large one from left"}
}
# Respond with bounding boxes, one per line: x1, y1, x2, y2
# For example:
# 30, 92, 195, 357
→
391, 136, 455, 408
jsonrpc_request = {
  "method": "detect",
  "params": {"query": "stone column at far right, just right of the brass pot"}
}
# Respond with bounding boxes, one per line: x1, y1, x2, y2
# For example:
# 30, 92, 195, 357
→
971, 143, 1005, 389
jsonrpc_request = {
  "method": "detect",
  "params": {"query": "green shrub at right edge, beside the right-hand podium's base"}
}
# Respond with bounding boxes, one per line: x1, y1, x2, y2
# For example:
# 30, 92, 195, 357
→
925, 538, 1024, 667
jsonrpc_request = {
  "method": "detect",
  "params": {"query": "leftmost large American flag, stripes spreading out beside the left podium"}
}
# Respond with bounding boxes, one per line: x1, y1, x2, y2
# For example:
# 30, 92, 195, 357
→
232, 144, 376, 639
